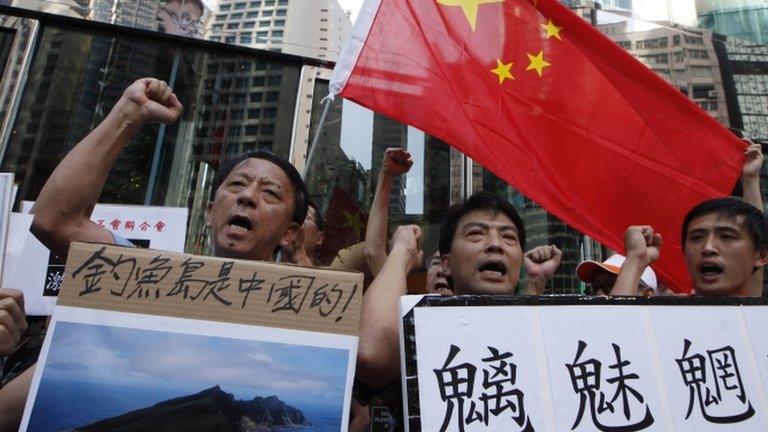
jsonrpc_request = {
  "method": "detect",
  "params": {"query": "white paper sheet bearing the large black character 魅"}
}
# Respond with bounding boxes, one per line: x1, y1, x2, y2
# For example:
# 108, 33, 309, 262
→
539, 306, 665, 432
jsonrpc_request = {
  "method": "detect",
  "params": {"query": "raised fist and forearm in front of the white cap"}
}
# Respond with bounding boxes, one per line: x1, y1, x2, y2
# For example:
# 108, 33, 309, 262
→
611, 225, 661, 296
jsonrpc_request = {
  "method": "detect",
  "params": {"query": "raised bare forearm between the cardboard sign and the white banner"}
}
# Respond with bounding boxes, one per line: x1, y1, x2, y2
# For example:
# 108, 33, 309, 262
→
357, 225, 421, 389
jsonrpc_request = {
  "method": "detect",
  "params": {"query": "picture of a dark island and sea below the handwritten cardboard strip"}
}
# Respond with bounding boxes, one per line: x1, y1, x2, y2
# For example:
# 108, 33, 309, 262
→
27, 321, 349, 432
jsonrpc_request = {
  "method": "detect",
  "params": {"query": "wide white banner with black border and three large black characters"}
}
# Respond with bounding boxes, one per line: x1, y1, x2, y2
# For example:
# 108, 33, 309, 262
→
400, 296, 768, 432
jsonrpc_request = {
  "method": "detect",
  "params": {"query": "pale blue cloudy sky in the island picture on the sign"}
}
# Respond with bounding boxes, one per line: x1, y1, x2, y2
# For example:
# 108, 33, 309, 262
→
43, 322, 348, 401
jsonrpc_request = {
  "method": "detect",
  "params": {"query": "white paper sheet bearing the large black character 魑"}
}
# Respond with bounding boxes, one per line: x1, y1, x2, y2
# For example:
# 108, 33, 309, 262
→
409, 306, 551, 432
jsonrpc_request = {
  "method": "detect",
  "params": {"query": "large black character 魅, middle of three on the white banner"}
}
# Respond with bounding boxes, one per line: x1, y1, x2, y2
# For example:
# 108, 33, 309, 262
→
565, 341, 654, 432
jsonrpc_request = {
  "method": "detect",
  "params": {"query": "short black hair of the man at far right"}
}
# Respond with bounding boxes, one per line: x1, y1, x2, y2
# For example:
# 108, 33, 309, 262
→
681, 197, 768, 251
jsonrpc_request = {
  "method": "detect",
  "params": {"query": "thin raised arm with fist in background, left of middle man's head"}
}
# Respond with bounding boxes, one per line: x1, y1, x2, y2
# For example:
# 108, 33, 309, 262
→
365, 148, 413, 277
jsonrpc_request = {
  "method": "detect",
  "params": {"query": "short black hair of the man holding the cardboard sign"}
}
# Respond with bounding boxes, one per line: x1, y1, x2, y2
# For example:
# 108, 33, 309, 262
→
210, 150, 307, 225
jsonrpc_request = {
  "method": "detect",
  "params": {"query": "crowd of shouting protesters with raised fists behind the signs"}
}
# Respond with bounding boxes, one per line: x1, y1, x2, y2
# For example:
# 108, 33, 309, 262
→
0, 78, 768, 431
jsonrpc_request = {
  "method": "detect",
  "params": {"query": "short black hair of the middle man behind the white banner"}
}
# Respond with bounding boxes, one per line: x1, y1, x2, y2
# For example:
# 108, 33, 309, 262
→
440, 192, 525, 255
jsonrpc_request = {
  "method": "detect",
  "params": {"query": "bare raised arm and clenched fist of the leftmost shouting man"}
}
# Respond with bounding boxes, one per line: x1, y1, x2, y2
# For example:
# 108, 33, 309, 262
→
31, 78, 182, 257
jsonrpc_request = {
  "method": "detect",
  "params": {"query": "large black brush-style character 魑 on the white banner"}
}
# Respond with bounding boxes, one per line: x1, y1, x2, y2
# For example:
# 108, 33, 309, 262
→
434, 345, 534, 432
